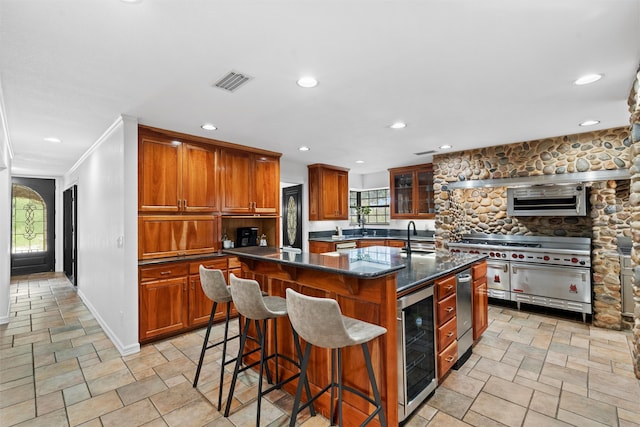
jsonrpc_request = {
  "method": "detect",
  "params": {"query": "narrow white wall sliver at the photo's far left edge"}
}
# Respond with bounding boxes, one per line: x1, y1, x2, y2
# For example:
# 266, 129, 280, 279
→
0, 132, 11, 324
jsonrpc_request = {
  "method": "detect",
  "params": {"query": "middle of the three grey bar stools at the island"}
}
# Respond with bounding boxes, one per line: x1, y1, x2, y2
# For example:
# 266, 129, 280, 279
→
224, 273, 316, 426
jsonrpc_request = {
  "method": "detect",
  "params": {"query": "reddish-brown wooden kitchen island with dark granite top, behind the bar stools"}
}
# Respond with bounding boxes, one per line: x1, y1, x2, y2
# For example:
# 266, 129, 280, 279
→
224, 246, 486, 425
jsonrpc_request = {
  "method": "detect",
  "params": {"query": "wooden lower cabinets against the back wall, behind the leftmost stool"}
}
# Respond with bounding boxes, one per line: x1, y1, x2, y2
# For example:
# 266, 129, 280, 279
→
138, 257, 240, 342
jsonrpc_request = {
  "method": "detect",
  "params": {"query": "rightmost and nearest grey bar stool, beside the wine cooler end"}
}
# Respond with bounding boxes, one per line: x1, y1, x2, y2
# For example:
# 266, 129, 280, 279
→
286, 288, 387, 427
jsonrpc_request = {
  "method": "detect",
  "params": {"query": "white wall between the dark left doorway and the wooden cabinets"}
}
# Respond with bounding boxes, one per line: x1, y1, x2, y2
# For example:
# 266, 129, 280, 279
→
62, 116, 140, 355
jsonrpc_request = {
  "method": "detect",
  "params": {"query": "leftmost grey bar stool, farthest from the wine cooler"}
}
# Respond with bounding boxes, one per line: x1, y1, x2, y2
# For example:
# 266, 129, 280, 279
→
193, 265, 271, 411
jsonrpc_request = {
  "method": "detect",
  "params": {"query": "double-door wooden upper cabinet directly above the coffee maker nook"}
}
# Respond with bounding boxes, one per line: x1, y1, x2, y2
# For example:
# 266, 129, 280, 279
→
220, 148, 280, 215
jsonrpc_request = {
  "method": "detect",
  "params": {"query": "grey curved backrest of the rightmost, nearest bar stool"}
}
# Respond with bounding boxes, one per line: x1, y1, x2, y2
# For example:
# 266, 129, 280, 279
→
286, 288, 353, 348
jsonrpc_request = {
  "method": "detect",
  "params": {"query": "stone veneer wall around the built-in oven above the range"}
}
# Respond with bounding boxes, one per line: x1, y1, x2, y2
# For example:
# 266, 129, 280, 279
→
433, 128, 640, 329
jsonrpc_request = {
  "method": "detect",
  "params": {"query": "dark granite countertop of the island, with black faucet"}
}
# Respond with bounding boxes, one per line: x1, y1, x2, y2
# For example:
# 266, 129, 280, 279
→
223, 246, 486, 293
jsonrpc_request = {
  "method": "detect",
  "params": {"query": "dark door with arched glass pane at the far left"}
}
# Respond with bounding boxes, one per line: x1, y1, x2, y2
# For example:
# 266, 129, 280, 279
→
11, 178, 56, 275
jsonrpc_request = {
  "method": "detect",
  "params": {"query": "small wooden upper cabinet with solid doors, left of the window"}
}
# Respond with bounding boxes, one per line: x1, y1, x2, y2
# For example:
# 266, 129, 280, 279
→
308, 164, 349, 221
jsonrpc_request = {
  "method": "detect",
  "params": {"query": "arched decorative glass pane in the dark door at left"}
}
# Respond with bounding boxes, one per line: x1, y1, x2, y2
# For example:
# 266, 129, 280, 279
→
11, 184, 47, 254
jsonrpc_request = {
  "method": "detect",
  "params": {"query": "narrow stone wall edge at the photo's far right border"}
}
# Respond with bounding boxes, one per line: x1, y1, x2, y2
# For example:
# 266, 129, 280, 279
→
629, 70, 640, 378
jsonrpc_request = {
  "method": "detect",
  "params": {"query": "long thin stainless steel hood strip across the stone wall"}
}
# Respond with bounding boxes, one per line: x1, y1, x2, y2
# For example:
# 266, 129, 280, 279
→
446, 169, 631, 190
